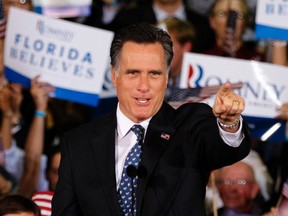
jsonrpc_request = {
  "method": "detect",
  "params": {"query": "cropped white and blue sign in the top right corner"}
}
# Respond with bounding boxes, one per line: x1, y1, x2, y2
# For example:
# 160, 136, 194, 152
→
255, 0, 288, 40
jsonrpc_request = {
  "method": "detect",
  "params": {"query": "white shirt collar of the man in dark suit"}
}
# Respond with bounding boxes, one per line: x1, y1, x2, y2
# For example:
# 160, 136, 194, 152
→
116, 103, 152, 140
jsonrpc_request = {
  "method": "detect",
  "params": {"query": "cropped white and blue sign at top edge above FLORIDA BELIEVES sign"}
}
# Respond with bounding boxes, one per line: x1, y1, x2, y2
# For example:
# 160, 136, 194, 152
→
32, 0, 92, 18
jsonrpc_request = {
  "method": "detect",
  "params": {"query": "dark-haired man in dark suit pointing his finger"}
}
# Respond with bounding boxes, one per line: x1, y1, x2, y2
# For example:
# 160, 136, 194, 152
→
52, 24, 250, 216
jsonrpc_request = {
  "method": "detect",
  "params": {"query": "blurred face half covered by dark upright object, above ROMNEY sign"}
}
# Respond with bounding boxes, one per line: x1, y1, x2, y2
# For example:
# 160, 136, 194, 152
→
210, 0, 248, 47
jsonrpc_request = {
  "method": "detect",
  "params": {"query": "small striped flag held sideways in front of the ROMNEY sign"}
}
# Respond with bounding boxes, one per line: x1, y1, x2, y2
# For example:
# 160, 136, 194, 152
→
167, 82, 243, 108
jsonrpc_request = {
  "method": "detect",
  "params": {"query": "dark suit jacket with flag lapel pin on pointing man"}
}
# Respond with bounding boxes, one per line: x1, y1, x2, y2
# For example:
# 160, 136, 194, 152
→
52, 103, 250, 216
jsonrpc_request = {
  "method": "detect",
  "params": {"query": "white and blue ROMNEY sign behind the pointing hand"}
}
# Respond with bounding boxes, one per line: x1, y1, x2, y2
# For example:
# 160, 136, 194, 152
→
180, 53, 288, 140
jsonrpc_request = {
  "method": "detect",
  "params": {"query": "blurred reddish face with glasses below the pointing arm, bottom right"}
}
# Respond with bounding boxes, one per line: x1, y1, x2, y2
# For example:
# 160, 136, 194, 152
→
216, 162, 259, 212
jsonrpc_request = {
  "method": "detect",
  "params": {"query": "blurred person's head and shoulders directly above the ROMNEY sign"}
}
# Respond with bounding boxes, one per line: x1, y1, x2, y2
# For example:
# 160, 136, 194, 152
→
203, 0, 265, 61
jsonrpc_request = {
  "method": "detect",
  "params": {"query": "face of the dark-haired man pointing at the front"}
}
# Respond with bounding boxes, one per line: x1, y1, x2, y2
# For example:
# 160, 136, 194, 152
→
112, 41, 168, 123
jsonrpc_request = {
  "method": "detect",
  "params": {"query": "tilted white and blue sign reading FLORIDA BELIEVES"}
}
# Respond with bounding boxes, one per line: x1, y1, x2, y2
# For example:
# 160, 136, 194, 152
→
4, 8, 114, 106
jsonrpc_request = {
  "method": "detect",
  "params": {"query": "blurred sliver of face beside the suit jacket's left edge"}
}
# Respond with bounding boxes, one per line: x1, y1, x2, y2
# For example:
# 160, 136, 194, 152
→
47, 152, 61, 191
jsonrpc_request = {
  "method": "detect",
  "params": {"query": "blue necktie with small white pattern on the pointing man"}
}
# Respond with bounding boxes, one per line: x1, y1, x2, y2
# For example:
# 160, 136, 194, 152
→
118, 125, 144, 216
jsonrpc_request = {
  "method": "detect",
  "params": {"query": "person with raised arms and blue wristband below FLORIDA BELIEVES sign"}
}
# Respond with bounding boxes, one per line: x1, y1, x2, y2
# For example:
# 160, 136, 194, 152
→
0, 78, 54, 197
